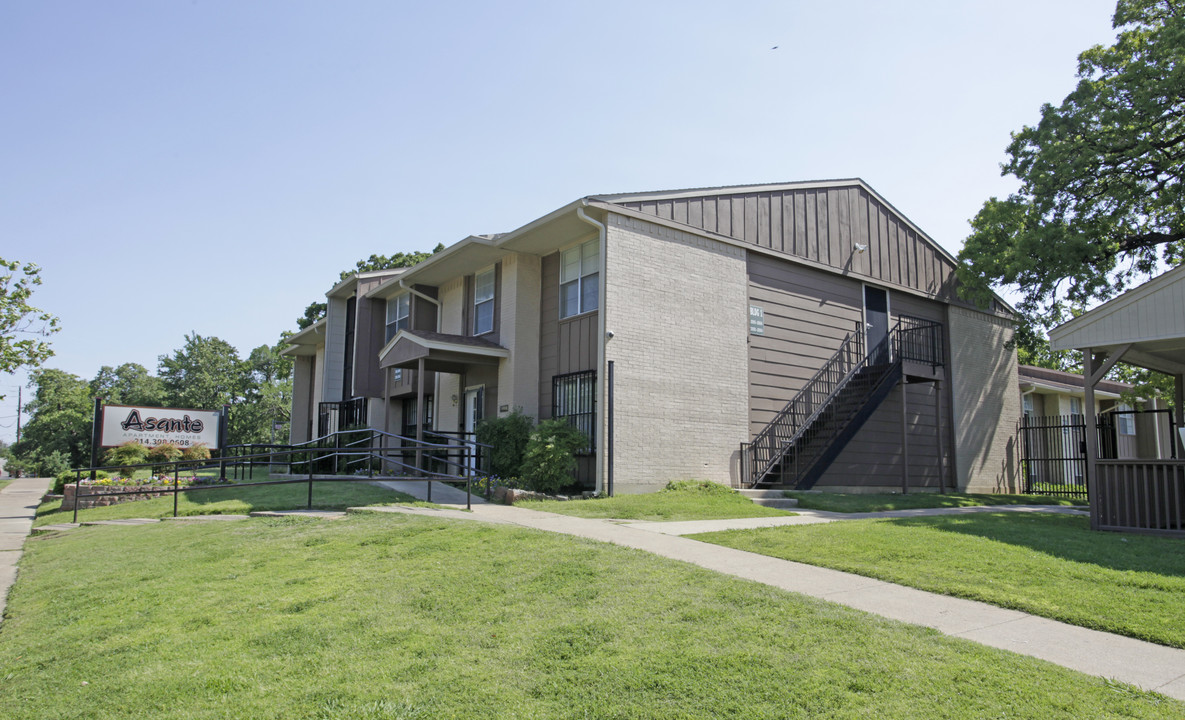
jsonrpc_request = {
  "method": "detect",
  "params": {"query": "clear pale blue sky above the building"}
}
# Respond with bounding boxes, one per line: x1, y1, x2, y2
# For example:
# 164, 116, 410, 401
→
0, 0, 1114, 441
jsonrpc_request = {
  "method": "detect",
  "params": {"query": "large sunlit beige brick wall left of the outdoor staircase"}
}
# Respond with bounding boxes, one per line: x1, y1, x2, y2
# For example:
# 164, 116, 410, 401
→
598, 214, 749, 493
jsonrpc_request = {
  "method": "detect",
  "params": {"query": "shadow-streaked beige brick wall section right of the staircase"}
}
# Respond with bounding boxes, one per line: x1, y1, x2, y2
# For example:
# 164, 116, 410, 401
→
947, 306, 1020, 493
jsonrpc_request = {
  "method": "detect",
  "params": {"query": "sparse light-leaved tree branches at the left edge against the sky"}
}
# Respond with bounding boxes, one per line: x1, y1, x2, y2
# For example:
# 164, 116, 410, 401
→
0, 257, 59, 399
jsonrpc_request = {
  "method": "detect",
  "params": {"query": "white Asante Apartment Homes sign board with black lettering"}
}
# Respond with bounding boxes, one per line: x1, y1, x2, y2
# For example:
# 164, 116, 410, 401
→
98, 405, 220, 450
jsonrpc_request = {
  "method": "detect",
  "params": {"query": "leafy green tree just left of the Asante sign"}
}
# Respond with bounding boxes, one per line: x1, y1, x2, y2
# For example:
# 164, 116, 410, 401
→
12, 368, 94, 468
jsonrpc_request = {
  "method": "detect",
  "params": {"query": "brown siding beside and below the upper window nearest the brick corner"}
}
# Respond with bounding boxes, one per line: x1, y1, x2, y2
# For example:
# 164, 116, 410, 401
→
539, 252, 597, 419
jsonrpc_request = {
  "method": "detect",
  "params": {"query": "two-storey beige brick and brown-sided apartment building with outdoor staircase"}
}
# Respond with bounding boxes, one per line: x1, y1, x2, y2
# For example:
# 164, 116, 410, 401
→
286, 180, 1020, 493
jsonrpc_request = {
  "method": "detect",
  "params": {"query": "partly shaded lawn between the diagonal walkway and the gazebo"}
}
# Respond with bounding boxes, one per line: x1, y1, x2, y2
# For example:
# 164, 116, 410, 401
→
694, 513, 1185, 648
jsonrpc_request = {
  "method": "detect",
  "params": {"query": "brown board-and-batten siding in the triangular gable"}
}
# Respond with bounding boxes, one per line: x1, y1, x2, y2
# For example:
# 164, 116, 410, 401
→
619, 184, 955, 301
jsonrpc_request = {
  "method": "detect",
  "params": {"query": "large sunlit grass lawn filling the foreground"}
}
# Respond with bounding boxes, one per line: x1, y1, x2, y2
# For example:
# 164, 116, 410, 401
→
0, 514, 1185, 720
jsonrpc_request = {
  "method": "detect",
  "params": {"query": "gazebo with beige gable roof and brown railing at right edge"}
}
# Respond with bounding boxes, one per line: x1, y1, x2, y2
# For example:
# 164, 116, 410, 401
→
1049, 265, 1185, 536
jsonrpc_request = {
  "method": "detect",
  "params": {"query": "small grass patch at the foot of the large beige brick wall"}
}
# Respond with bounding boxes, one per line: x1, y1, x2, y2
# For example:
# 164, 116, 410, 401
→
514, 481, 794, 521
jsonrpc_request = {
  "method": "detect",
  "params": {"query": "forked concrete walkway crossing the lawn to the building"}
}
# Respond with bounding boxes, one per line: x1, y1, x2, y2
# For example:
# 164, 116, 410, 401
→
357, 483, 1185, 700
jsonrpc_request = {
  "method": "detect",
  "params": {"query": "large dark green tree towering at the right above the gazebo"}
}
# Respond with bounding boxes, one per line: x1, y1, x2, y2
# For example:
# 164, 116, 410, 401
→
959, 0, 1185, 333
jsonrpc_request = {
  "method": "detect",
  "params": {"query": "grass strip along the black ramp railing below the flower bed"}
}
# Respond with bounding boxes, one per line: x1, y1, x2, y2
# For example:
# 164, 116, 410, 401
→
33, 481, 425, 527
